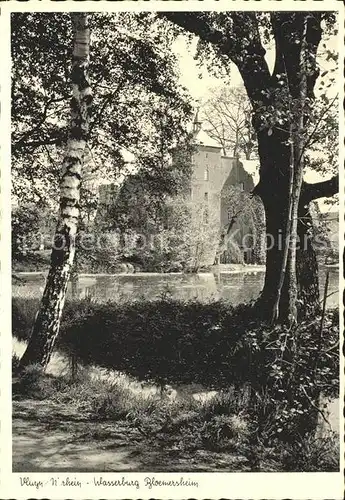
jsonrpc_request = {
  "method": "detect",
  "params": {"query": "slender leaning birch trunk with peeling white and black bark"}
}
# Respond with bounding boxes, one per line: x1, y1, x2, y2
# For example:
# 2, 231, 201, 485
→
20, 13, 92, 369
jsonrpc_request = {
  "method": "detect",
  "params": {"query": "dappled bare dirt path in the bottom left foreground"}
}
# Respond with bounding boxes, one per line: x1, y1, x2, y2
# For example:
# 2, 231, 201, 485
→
12, 400, 249, 472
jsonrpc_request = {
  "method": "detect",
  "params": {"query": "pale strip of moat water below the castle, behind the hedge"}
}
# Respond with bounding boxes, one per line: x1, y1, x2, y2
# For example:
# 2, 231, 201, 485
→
69, 270, 338, 307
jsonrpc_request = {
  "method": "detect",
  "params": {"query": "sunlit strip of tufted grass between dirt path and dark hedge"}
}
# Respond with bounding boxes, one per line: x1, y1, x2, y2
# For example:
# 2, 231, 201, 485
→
14, 358, 339, 471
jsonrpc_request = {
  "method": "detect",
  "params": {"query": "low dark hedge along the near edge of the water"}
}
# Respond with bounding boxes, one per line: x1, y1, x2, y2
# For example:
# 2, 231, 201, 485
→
12, 298, 339, 398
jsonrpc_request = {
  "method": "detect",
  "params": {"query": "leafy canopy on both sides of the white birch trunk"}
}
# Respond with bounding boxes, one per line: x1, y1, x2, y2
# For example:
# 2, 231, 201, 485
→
11, 12, 191, 205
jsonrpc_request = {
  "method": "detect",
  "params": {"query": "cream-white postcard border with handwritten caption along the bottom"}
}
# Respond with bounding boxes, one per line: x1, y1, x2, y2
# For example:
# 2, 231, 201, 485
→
0, 0, 345, 500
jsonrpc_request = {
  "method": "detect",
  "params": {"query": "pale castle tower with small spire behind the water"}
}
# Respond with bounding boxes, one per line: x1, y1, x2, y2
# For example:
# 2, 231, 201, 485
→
98, 112, 258, 266
